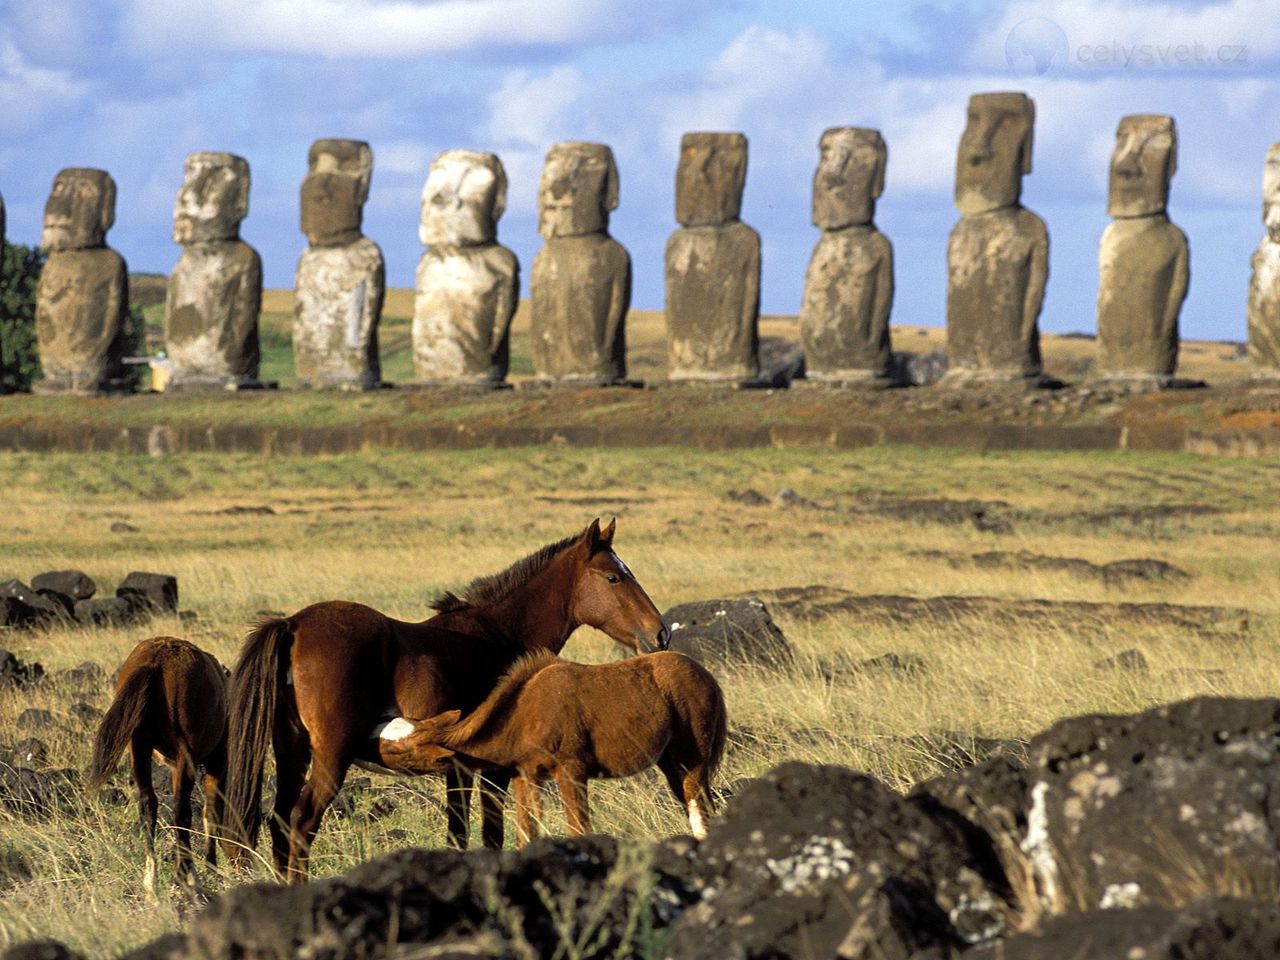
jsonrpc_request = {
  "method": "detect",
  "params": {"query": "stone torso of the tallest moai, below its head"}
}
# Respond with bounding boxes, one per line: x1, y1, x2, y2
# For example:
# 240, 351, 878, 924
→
947, 207, 1048, 378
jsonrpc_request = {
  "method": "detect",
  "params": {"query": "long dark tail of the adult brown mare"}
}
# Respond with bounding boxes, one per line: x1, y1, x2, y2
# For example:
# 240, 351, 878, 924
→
225, 620, 293, 850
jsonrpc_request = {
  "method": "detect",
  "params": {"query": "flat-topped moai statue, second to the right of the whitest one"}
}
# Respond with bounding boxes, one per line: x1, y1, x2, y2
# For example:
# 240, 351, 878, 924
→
666, 133, 760, 384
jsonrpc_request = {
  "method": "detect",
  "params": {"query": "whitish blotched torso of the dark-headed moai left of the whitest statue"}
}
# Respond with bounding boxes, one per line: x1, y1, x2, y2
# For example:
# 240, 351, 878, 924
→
293, 237, 385, 389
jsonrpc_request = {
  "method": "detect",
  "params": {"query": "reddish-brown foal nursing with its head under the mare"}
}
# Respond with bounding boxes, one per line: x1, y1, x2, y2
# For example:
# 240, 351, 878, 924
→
381, 652, 726, 846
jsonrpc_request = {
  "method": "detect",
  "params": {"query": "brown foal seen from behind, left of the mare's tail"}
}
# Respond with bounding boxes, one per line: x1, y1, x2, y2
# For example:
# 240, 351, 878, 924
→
88, 636, 229, 896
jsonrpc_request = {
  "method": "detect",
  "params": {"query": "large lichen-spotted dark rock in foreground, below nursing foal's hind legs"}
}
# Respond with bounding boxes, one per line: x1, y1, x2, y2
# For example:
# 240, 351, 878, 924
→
669, 763, 1004, 960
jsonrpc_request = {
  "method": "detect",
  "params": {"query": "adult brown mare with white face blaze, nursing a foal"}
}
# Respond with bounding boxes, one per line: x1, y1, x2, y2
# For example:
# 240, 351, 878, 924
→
228, 521, 669, 882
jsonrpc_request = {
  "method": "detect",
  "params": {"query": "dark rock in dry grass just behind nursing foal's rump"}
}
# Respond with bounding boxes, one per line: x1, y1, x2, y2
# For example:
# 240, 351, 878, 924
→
662, 596, 792, 666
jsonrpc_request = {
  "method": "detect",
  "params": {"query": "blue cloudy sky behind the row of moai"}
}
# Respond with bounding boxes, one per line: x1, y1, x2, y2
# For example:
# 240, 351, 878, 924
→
0, 0, 1280, 339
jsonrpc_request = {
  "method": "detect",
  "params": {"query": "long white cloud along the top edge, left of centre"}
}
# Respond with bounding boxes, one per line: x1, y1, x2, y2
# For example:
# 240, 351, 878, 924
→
125, 0, 670, 59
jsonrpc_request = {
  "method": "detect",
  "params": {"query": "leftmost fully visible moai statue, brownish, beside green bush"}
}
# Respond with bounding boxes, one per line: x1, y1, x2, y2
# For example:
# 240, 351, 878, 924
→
35, 168, 129, 393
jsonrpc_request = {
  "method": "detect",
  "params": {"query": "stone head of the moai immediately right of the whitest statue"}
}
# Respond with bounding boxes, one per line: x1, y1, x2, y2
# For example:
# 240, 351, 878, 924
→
538, 142, 618, 239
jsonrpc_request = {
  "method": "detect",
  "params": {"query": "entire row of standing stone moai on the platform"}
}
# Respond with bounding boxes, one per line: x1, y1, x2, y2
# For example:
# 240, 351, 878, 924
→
0, 92, 1280, 392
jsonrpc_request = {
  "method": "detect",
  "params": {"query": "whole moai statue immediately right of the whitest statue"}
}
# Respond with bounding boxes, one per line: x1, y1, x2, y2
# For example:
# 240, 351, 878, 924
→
531, 143, 631, 385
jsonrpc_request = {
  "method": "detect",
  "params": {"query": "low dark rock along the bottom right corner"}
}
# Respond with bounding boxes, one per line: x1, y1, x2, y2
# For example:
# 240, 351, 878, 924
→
964, 900, 1280, 960
